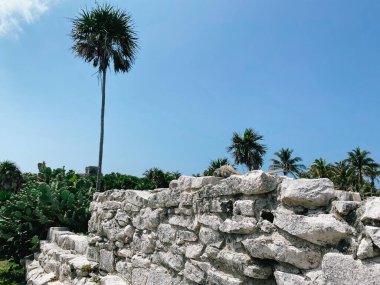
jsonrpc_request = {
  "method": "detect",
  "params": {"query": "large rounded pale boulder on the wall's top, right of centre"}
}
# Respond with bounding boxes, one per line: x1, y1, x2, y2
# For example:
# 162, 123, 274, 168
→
281, 178, 335, 208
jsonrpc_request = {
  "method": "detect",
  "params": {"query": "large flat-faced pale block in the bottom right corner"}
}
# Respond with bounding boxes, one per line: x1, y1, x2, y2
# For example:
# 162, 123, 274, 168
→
322, 253, 380, 285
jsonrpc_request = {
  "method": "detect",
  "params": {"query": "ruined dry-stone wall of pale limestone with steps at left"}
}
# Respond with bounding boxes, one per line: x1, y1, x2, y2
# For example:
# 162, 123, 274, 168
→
27, 171, 380, 285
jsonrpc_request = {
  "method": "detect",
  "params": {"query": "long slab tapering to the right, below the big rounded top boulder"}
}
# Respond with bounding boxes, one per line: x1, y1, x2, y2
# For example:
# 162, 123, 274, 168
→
273, 213, 354, 245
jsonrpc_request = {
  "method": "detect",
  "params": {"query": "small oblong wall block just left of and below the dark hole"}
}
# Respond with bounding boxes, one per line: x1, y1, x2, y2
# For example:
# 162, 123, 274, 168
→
219, 216, 257, 234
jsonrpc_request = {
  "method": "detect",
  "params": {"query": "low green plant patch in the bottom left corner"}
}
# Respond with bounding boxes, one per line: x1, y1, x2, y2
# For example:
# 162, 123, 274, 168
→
0, 260, 26, 285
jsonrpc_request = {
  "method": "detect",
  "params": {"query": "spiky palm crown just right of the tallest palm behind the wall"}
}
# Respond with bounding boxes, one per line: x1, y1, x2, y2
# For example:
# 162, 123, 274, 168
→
269, 148, 306, 177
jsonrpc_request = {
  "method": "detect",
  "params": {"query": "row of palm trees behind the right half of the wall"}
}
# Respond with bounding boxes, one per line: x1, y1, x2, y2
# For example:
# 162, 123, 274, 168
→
202, 128, 380, 196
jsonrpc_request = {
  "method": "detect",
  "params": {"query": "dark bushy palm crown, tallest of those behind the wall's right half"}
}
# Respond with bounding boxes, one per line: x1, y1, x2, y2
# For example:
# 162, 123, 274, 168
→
227, 128, 267, 171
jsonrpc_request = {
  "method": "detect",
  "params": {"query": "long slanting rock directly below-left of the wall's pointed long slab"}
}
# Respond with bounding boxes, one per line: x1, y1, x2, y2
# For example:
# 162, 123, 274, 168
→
242, 233, 321, 269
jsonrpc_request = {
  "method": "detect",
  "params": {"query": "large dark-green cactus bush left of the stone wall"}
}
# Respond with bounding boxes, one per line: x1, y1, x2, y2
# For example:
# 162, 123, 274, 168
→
0, 163, 94, 262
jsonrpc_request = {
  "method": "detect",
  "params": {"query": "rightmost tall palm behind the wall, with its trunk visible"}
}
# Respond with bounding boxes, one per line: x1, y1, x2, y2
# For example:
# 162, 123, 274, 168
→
347, 147, 376, 191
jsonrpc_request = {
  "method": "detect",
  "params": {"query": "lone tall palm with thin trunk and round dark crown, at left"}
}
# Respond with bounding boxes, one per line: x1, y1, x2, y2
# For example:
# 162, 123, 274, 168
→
71, 4, 138, 191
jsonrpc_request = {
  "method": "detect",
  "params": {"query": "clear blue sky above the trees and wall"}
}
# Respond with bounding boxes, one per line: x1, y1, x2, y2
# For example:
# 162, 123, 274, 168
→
0, 0, 380, 175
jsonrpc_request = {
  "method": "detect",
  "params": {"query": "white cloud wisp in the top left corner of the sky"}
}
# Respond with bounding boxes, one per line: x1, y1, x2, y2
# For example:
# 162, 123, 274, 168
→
0, 0, 55, 37
